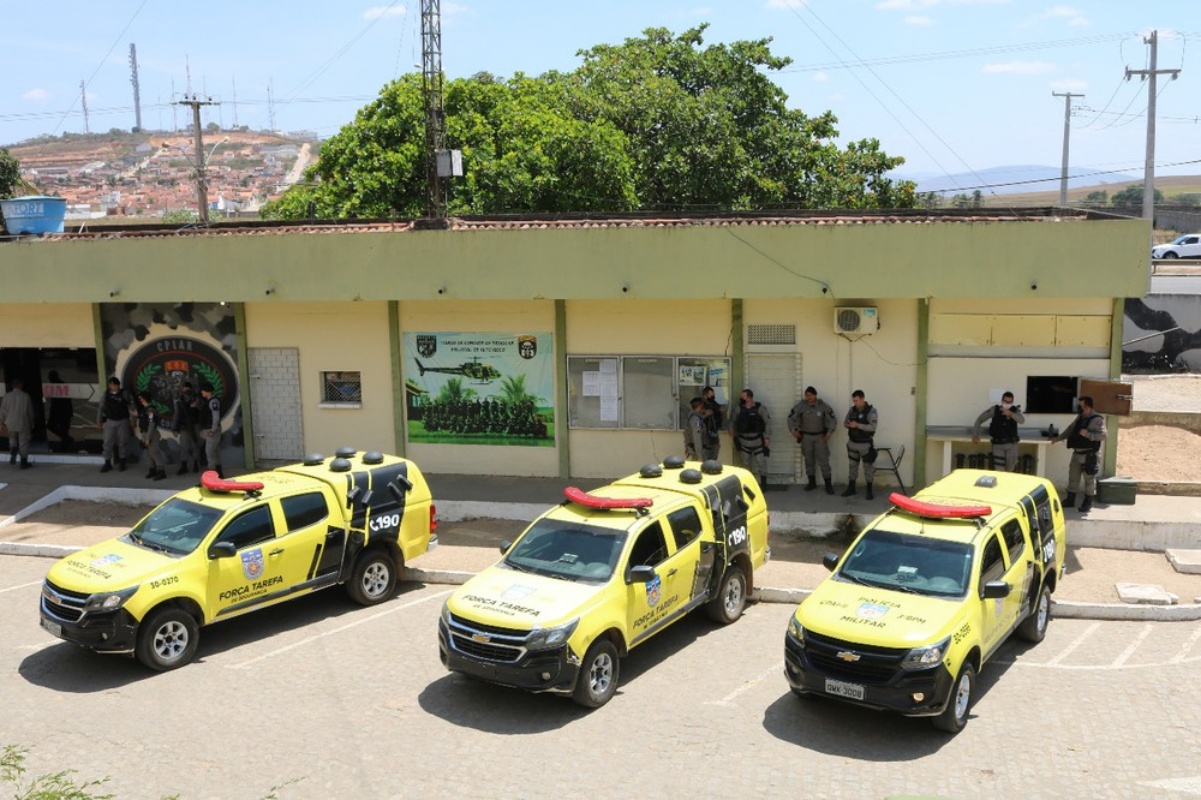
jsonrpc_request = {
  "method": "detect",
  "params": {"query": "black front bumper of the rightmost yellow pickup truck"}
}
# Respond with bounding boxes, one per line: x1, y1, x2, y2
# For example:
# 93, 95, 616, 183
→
784, 633, 955, 717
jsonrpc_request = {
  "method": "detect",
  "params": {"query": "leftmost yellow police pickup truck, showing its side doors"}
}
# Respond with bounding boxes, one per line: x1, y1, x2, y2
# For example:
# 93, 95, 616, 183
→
41, 448, 437, 670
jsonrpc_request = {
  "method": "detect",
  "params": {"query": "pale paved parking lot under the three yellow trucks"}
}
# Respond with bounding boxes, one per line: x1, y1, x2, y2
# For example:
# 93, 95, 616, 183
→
0, 557, 1201, 800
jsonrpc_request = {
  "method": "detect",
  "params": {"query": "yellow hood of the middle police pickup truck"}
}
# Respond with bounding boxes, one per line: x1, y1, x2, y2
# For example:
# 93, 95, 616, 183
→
447, 566, 605, 628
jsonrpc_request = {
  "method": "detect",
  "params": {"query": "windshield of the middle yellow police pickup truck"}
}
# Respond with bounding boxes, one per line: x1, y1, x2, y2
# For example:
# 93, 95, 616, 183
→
503, 519, 626, 583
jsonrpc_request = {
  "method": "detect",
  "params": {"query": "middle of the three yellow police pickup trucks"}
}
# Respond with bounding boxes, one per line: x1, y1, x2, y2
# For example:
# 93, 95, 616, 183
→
438, 456, 770, 708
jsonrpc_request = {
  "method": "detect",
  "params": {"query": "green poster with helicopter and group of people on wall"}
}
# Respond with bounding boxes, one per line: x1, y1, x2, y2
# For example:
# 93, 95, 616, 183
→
404, 333, 555, 447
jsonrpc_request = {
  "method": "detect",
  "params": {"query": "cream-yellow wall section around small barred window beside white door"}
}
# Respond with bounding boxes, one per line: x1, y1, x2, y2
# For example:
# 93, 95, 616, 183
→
245, 303, 394, 454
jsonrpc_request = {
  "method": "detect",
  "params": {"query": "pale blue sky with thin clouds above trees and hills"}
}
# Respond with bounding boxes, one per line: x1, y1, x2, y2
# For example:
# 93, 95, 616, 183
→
0, 0, 1201, 191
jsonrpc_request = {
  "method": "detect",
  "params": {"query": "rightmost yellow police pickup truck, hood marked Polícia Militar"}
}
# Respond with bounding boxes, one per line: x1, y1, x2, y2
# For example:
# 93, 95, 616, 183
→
784, 470, 1066, 733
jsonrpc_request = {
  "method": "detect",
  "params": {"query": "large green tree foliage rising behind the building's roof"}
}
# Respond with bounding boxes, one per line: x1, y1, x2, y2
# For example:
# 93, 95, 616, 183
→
263, 26, 915, 219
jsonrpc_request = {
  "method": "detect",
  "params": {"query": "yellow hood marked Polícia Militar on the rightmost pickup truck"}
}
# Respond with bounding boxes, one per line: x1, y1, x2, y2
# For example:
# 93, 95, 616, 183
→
796, 577, 962, 647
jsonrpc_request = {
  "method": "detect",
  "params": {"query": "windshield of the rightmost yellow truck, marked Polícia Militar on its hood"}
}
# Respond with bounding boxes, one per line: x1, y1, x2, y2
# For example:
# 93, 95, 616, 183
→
838, 530, 972, 597
